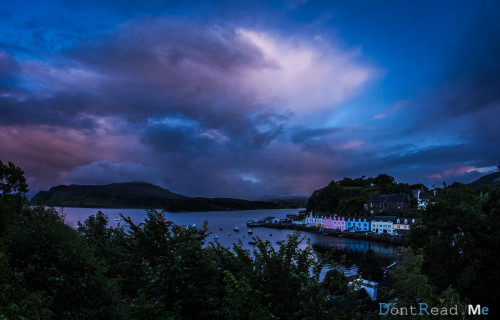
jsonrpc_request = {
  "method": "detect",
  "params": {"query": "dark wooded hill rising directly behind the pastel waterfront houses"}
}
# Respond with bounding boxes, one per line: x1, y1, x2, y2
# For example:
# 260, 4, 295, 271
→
307, 174, 428, 216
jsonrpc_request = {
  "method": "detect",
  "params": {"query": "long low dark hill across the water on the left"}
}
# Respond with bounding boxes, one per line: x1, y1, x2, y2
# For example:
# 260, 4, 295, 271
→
31, 182, 284, 211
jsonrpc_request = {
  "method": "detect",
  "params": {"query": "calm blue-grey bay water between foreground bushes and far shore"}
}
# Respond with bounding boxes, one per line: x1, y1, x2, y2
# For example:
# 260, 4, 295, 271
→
58, 208, 396, 263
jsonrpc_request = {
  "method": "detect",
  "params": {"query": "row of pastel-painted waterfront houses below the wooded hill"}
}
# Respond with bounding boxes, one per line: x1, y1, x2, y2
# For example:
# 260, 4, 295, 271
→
300, 213, 415, 234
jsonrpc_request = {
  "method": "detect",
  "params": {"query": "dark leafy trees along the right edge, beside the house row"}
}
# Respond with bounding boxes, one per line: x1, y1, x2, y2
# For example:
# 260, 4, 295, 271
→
392, 182, 500, 319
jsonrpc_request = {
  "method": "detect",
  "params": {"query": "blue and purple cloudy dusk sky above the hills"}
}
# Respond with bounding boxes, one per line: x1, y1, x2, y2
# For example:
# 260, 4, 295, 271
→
0, 0, 500, 199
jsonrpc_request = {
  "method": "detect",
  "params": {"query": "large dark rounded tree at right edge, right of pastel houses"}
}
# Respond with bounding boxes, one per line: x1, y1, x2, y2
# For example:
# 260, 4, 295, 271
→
408, 183, 500, 305
